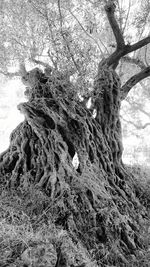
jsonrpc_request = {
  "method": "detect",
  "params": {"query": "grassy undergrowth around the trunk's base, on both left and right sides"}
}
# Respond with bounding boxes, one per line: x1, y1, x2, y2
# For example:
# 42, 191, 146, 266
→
0, 166, 150, 267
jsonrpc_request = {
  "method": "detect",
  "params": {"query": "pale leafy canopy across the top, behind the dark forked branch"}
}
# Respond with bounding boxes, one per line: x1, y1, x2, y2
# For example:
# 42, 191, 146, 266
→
0, 0, 148, 77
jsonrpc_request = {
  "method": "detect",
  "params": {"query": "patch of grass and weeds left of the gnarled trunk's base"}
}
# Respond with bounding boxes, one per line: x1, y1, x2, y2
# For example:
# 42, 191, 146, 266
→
0, 188, 96, 267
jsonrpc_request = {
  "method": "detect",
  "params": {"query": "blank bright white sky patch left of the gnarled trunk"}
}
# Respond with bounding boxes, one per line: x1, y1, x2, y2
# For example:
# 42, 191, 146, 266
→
0, 79, 26, 152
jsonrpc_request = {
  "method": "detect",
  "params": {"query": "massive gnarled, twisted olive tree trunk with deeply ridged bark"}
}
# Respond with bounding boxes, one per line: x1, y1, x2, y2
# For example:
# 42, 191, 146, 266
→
0, 65, 146, 267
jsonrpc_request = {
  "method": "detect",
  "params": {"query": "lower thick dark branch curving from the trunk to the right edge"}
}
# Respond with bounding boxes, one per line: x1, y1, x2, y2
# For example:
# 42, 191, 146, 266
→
121, 66, 150, 100
